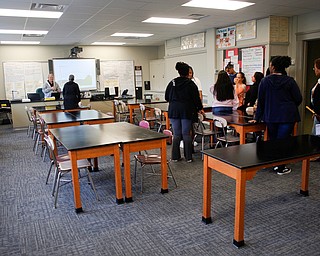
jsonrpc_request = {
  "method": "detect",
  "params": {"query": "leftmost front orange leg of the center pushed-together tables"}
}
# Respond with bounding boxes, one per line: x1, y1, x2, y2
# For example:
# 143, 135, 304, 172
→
69, 151, 83, 213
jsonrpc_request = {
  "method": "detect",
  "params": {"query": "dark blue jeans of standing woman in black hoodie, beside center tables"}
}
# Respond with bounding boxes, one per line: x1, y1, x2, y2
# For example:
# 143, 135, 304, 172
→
170, 118, 192, 160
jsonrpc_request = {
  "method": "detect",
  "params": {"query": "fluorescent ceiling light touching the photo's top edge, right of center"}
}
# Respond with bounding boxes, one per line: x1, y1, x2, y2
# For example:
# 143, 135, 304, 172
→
182, 0, 254, 11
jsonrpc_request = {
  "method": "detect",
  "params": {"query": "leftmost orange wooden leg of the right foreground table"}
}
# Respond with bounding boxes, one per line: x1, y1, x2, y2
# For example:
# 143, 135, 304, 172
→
202, 155, 212, 224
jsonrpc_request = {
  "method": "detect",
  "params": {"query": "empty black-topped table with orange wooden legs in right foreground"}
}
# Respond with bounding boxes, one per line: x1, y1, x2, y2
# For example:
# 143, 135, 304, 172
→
202, 135, 320, 247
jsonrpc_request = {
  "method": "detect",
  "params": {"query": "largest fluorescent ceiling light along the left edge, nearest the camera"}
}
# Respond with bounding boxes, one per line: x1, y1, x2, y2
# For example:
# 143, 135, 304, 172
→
0, 9, 63, 19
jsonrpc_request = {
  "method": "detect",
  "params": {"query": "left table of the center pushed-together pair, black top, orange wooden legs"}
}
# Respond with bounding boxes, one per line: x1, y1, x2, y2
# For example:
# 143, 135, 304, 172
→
51, 124, 123, 213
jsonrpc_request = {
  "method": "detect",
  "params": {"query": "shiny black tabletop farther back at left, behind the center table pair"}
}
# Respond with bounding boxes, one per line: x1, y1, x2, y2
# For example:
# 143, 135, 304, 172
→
41, 110, 114, 124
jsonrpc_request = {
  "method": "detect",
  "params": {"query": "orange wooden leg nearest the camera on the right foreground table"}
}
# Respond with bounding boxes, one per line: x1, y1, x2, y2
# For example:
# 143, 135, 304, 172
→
233, 170, 246, 247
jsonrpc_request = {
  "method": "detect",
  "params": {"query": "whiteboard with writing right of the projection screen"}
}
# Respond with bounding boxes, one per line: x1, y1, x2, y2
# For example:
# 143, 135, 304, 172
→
100, 60, 135, 96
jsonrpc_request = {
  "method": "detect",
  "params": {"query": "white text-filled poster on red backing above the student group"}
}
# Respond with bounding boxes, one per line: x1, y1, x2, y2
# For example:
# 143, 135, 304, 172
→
241, 46, 264, 84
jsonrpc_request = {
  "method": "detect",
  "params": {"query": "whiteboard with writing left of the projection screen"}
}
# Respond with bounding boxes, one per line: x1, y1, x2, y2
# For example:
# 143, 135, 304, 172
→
3, 61, 48, 100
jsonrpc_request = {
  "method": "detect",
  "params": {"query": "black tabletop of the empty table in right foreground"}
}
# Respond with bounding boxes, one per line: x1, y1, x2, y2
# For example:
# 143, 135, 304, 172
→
203, 135, 320, 169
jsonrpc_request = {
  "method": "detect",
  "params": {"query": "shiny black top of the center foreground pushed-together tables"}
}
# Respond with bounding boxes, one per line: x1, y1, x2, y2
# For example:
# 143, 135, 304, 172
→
50, 122, 167, 151
